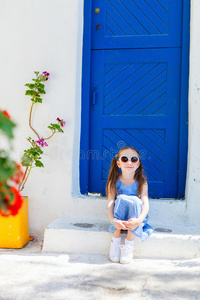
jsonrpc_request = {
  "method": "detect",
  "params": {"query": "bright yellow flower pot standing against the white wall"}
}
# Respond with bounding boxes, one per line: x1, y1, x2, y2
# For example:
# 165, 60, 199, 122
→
0, 197, 29, 248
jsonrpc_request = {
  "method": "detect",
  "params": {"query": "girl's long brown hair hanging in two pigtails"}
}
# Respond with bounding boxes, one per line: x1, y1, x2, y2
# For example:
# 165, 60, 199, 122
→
106, 146, 147, 197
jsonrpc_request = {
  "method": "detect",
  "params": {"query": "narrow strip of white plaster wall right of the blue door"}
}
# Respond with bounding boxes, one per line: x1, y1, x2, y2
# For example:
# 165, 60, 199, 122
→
186, 0, 200, 223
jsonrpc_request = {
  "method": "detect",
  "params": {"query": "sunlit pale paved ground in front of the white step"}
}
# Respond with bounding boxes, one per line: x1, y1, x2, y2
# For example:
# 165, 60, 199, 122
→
0, 241, 200, 300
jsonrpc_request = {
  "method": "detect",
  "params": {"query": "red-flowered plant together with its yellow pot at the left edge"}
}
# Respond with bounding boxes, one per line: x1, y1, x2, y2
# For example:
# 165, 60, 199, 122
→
0, 111, 29, 248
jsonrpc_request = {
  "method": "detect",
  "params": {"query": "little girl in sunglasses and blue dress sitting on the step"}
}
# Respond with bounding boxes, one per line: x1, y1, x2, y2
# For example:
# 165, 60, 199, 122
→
106, 146, 153, 263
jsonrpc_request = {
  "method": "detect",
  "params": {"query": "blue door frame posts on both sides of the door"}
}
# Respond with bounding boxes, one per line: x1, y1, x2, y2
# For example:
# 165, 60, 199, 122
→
79, 0, 190, 199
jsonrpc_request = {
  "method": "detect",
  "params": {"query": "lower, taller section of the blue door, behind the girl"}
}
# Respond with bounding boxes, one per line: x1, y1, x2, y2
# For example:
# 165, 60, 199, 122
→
89, 48, 181, 197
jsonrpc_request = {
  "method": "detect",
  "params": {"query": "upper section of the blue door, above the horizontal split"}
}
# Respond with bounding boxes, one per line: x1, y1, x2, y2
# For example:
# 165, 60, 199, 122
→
92, 0, 182, 49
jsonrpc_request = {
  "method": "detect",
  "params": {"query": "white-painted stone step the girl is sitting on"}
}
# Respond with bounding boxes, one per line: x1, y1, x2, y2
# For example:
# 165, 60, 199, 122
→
43, 216, 200, 259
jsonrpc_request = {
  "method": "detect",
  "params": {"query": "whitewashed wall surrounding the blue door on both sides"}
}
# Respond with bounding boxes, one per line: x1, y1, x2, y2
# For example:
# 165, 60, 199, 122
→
0, 0, 200, 234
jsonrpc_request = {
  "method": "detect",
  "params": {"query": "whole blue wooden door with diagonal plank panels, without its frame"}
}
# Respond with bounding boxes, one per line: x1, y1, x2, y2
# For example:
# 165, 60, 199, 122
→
80, 0, 188, 198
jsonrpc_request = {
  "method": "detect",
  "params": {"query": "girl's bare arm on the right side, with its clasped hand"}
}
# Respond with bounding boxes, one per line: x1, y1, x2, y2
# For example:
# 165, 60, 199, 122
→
125, 183, 149, 230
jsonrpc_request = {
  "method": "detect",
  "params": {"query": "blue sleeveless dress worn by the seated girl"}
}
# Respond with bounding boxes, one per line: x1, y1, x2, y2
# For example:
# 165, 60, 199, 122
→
108, 179, 153, 242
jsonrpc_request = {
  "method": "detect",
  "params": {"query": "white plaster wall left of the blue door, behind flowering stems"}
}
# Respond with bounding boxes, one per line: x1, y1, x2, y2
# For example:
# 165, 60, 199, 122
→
0, 0, 83, 234
